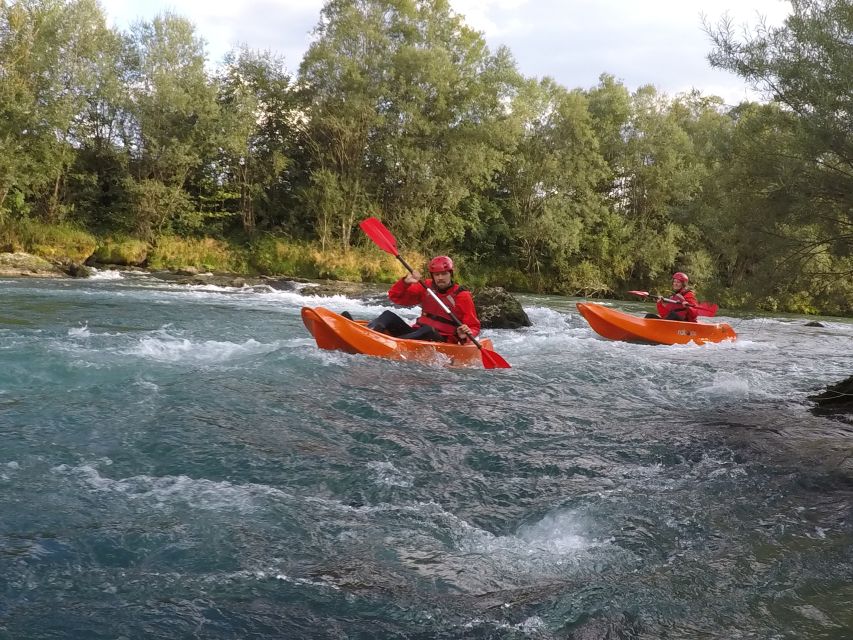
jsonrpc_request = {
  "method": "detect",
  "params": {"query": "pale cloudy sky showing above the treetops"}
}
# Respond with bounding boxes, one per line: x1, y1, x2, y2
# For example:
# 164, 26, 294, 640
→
102, 0, 790, 104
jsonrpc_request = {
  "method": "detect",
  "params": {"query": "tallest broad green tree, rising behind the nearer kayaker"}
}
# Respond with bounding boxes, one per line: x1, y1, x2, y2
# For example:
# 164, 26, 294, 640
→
300, 0, 517, 247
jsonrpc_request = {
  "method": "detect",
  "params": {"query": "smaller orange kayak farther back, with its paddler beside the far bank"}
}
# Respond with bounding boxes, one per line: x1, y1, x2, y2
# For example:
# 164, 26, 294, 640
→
577, 302, 737, 344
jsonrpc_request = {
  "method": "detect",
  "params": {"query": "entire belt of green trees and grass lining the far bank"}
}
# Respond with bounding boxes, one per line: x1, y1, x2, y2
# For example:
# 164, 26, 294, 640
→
0, 0, 853, 314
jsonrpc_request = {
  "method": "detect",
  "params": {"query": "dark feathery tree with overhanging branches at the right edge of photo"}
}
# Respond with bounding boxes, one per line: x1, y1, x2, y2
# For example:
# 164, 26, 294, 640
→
706, 0, 853, 312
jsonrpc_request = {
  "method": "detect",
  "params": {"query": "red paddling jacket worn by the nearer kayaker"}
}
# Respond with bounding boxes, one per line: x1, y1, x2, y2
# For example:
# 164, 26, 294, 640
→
388, 278, 480, 343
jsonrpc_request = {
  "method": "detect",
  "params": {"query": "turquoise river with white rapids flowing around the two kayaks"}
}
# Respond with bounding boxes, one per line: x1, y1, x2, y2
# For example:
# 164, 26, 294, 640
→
0, 271, 853, 640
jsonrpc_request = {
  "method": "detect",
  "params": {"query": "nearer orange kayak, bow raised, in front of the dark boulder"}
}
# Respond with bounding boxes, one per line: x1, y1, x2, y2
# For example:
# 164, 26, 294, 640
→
302, 307, 493, 366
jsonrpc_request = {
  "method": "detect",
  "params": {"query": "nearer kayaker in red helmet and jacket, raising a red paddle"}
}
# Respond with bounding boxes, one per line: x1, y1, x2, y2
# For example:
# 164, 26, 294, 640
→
367, 256, 480, 344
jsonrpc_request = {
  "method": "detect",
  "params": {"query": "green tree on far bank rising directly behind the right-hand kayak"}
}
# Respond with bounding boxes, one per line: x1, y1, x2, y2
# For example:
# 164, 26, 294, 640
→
587, 75, 704, 286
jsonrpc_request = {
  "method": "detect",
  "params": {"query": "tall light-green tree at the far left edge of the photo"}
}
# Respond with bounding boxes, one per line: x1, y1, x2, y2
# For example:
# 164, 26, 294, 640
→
0, 0, 112, 221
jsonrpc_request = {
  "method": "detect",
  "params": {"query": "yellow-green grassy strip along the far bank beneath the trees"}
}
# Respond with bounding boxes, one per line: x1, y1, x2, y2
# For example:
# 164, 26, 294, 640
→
0, 221, 845, 315
